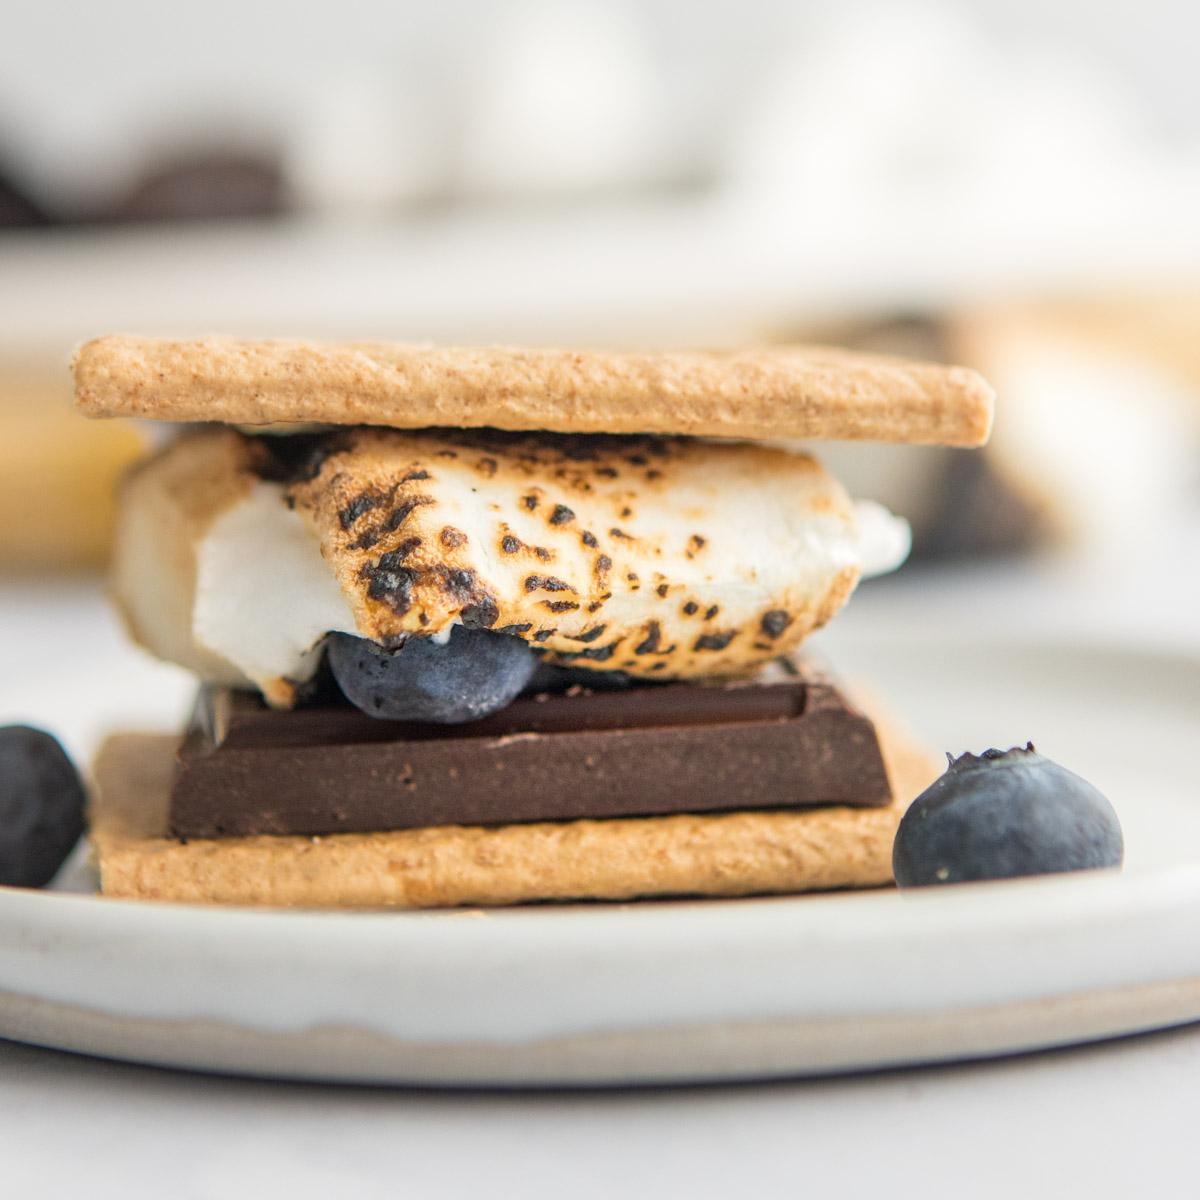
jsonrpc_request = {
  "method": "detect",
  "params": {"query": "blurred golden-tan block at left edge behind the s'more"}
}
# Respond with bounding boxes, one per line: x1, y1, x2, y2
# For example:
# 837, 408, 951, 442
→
0, 353, 146, 576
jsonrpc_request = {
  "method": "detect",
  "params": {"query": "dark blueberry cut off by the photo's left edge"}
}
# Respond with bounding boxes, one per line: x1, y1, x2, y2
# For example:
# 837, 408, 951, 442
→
0, 725, 84, 888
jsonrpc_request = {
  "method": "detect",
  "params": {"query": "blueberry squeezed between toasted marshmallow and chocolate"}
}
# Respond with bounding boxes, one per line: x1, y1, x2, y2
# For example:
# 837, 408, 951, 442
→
329, 625, 536, 725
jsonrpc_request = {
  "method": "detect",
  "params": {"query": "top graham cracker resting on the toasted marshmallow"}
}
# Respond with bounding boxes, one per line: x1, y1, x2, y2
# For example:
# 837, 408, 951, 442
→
74, 336, 992, 446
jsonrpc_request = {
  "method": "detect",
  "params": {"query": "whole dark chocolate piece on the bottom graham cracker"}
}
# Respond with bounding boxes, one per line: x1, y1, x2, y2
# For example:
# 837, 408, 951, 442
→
169, 676, 892, 838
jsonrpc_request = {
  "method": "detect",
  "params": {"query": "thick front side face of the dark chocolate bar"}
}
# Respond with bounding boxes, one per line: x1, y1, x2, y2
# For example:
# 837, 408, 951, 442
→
169, 680, 892, 838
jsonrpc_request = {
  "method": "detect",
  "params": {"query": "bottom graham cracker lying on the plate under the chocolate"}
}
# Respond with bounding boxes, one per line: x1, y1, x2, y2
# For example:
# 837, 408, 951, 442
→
91, 710, 941, 908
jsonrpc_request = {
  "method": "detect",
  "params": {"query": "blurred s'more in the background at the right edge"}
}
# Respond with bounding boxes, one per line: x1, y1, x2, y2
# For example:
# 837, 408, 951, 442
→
787, 297, 1200, 560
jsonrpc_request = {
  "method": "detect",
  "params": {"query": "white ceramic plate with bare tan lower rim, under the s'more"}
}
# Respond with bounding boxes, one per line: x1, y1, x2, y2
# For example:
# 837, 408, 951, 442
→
0, 636, 1200, 1085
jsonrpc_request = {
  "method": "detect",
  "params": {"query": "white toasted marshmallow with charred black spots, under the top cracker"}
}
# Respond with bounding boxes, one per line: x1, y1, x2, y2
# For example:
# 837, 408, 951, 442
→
193, 430, 910, 685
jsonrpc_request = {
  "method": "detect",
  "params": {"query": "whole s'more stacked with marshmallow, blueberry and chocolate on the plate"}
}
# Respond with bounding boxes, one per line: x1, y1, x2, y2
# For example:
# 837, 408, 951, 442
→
73, 336, 992, 908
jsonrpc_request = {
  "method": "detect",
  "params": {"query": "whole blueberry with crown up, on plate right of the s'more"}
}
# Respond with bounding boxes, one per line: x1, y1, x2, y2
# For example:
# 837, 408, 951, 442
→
892, 742, 1124, 887
